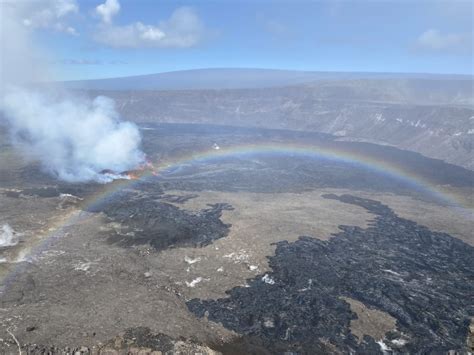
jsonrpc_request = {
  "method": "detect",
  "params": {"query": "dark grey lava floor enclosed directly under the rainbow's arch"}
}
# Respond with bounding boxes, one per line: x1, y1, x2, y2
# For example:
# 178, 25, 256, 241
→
159, 154, 426, 199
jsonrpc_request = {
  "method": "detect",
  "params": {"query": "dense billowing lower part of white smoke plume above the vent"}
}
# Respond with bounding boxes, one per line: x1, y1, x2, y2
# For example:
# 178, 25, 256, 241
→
3, 89, 144, 181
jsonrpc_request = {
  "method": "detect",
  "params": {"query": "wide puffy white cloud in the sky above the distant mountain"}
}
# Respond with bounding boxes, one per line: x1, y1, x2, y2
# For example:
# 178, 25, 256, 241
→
94, 7, 205, 48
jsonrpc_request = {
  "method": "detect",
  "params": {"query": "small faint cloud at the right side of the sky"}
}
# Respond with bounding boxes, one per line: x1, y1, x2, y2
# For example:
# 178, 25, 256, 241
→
417, 29, 472, 51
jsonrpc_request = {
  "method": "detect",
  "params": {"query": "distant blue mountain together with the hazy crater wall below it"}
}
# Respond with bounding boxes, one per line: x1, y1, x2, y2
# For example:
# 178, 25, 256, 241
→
59, 69, 474, 170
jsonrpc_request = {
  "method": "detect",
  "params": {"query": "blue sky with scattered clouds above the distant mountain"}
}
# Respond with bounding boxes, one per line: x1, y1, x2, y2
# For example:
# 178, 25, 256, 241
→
0, 0, 474, 80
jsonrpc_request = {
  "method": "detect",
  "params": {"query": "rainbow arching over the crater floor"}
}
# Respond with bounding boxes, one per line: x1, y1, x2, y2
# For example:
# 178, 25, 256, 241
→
4, 143, 473, 286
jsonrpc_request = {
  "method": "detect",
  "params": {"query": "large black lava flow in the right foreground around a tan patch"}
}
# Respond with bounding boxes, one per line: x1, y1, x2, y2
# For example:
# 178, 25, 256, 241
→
188, 195, 474, 354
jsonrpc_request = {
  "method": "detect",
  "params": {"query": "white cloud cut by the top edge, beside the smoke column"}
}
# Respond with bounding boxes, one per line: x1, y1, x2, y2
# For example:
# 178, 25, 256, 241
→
19, 0, 79, 36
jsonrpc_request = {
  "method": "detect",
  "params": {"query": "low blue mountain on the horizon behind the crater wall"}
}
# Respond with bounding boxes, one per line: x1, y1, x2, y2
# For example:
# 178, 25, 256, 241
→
62, 68, 473, 90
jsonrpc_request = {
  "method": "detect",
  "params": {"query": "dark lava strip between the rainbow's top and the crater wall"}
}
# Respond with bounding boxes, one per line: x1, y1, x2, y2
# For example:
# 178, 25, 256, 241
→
141, 123, 474, 187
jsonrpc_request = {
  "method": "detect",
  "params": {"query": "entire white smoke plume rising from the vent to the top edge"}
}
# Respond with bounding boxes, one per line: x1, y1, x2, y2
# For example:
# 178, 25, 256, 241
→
0, 0, 144, 182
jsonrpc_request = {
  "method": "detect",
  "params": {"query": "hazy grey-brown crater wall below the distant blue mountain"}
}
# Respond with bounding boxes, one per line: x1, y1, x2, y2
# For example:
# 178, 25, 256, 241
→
83, 79, 474, 170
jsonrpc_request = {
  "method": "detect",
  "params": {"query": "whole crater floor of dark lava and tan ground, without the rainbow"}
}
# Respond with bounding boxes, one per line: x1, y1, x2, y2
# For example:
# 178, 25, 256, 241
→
0, 125, 474, 354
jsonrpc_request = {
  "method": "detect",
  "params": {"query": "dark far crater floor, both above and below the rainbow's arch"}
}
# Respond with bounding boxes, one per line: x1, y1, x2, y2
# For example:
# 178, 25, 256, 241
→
0, 123, 474, 203
